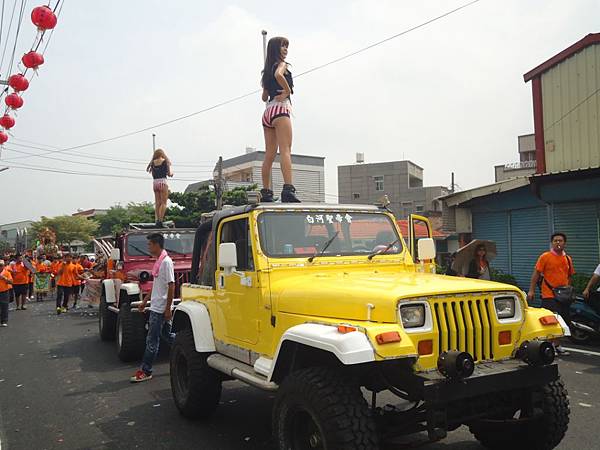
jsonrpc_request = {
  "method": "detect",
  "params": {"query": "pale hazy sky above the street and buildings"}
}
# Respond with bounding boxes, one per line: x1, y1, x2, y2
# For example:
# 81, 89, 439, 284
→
0, 0, 600, 223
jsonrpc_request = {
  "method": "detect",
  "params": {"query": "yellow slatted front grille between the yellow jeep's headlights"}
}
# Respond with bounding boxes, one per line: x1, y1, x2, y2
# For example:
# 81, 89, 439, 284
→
431, 298, 494, 361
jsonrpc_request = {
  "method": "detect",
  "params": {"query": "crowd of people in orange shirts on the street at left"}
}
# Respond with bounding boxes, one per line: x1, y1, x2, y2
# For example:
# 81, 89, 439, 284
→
0, 253, 96, 327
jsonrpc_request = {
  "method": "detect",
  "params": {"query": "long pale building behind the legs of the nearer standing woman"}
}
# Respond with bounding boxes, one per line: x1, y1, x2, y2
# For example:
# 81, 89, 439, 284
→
185, 148, 325, 203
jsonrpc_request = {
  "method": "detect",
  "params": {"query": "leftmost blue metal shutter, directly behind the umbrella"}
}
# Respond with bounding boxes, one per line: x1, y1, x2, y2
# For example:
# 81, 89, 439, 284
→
472, 211, 510, 273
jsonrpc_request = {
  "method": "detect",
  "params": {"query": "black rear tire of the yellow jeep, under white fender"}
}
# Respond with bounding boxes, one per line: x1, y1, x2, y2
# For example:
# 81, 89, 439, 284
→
170, 328, 222, 419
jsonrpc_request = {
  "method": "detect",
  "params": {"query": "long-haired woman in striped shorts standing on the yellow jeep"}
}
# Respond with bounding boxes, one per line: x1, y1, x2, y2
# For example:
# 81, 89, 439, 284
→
260, 37, 300, 203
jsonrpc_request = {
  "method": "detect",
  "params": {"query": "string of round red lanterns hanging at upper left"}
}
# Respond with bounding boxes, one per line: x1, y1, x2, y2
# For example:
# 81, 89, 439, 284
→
0, 0, 60, 145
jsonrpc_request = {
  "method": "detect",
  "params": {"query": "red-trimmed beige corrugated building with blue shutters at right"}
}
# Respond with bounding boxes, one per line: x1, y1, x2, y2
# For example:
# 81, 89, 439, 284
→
444, 33, 600, 298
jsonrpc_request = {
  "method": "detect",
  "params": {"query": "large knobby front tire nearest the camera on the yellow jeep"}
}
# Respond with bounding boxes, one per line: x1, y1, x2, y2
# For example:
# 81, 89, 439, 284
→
272, 367, 379, 450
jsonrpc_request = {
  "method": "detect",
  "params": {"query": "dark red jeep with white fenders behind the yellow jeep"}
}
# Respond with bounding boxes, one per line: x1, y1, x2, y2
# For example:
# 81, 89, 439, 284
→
96, 224, 195, 362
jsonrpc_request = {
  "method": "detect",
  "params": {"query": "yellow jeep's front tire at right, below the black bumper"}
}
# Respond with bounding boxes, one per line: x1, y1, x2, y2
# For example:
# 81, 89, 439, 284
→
469, 379, 571, 450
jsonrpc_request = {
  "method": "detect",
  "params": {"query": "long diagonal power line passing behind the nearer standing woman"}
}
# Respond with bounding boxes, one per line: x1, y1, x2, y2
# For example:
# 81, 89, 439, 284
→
10, 0, 480, 159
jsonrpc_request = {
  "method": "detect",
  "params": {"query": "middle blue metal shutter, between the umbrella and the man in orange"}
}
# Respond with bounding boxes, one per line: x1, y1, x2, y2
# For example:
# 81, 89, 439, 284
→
510, 207, 550, 291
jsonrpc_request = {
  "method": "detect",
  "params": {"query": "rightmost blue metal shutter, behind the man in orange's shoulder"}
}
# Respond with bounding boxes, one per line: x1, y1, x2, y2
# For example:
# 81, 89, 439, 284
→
554, 202, 600, 274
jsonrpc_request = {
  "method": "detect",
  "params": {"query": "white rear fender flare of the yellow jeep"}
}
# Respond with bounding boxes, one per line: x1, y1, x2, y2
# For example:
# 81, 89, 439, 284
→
172, 301, 216, 353
